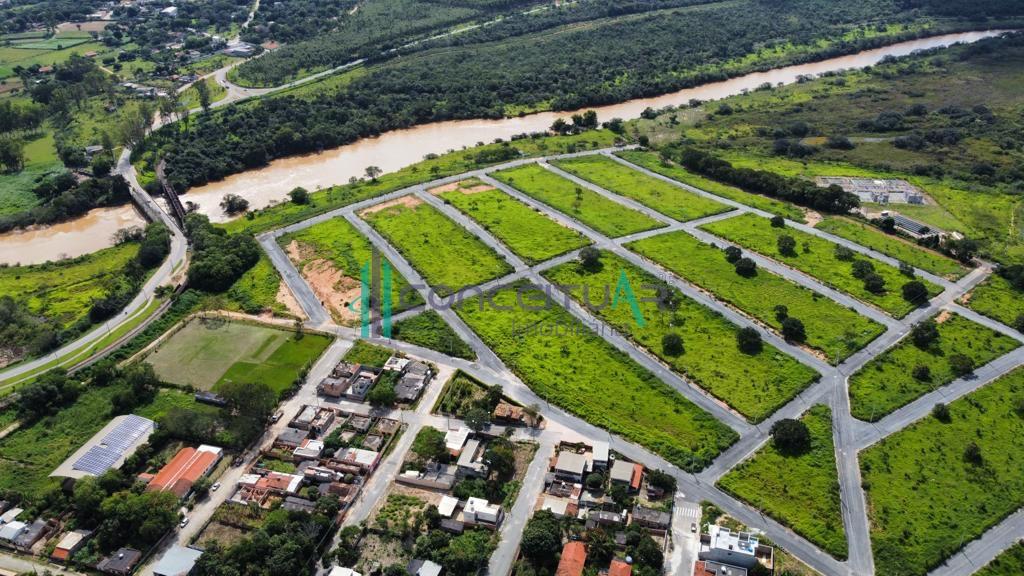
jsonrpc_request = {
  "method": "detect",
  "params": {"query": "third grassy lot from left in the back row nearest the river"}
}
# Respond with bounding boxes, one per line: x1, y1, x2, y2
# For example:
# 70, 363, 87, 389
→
490, 164, 663, 238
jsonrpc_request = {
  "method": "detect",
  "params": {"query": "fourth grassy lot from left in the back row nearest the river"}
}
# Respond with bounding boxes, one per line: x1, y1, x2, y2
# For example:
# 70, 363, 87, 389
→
554, 155, 732, 221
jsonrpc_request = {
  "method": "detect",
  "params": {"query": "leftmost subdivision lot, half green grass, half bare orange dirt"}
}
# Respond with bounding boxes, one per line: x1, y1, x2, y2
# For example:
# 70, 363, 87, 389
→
278, 218, 423, 326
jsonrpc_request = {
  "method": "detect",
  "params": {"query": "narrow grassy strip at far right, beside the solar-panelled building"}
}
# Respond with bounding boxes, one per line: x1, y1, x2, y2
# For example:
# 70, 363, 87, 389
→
814, 216, 968, 280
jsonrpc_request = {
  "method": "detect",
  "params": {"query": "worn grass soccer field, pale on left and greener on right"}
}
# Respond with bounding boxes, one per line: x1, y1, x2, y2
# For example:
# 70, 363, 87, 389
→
145, 319, 331, 394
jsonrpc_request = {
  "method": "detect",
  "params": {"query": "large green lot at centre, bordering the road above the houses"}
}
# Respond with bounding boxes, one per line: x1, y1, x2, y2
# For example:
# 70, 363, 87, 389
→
457, 283, 737, 470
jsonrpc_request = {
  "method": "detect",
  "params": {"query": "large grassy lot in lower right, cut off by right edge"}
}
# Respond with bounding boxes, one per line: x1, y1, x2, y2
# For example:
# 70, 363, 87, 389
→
860, 369, 1024, 576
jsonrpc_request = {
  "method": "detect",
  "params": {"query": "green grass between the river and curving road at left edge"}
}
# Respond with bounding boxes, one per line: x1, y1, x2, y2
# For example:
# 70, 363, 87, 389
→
0, 243, 138, 328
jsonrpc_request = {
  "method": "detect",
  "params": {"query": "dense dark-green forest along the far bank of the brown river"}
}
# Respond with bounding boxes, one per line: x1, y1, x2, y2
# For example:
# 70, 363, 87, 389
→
145, 0, 1024, 189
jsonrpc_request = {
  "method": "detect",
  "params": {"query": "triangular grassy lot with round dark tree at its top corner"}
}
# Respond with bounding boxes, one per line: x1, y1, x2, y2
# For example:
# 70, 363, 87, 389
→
718, 405, 847, 560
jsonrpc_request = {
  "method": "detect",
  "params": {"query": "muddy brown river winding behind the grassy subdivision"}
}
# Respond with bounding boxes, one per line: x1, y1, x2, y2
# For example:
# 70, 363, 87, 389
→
0, 31, 1005, 263
